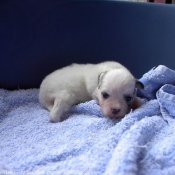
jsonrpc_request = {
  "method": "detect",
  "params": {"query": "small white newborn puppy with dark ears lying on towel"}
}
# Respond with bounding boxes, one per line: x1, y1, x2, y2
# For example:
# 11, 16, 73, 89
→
39, 61, 144, 122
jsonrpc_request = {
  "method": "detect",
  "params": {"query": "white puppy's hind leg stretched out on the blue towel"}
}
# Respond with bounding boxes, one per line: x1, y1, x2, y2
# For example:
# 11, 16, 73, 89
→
50, 92, 76, 122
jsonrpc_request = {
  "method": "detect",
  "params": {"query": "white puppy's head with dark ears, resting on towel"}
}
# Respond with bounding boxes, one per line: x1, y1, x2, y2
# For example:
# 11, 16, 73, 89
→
96, 69, 143, 118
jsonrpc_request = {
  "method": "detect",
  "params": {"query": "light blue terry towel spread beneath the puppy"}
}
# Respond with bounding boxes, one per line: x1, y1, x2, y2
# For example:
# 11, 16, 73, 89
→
0, 66, 175, 175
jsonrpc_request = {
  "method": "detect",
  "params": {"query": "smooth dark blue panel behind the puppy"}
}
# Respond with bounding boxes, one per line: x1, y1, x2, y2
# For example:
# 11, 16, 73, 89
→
0, 0, 175, 89
